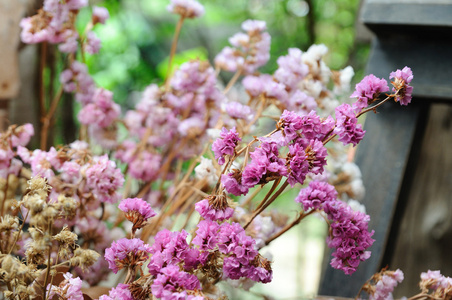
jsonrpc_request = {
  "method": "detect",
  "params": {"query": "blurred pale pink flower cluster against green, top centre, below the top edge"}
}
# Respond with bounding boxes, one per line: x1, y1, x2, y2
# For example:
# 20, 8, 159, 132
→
215, 20, 271, 74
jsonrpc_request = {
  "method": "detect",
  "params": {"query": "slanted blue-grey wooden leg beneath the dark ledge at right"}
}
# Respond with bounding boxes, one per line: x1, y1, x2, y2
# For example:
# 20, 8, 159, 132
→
319, 101, 427, 297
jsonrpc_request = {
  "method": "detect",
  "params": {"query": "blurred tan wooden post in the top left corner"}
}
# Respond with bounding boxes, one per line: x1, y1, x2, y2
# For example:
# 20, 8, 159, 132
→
0, 0, 27, 131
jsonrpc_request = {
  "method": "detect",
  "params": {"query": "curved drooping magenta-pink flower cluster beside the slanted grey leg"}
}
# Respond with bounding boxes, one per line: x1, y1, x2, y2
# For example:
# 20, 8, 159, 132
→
295, 181, 374, 274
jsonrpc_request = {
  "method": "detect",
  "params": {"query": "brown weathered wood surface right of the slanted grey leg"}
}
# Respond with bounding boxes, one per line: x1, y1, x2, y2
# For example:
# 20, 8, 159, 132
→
390, 104, 452, 297
